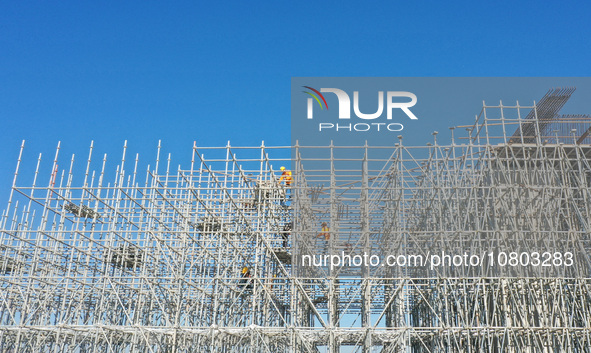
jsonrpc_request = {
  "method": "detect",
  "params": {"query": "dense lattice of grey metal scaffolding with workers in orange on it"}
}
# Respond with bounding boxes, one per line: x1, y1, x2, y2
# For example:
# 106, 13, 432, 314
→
0, 88, 591, 353
